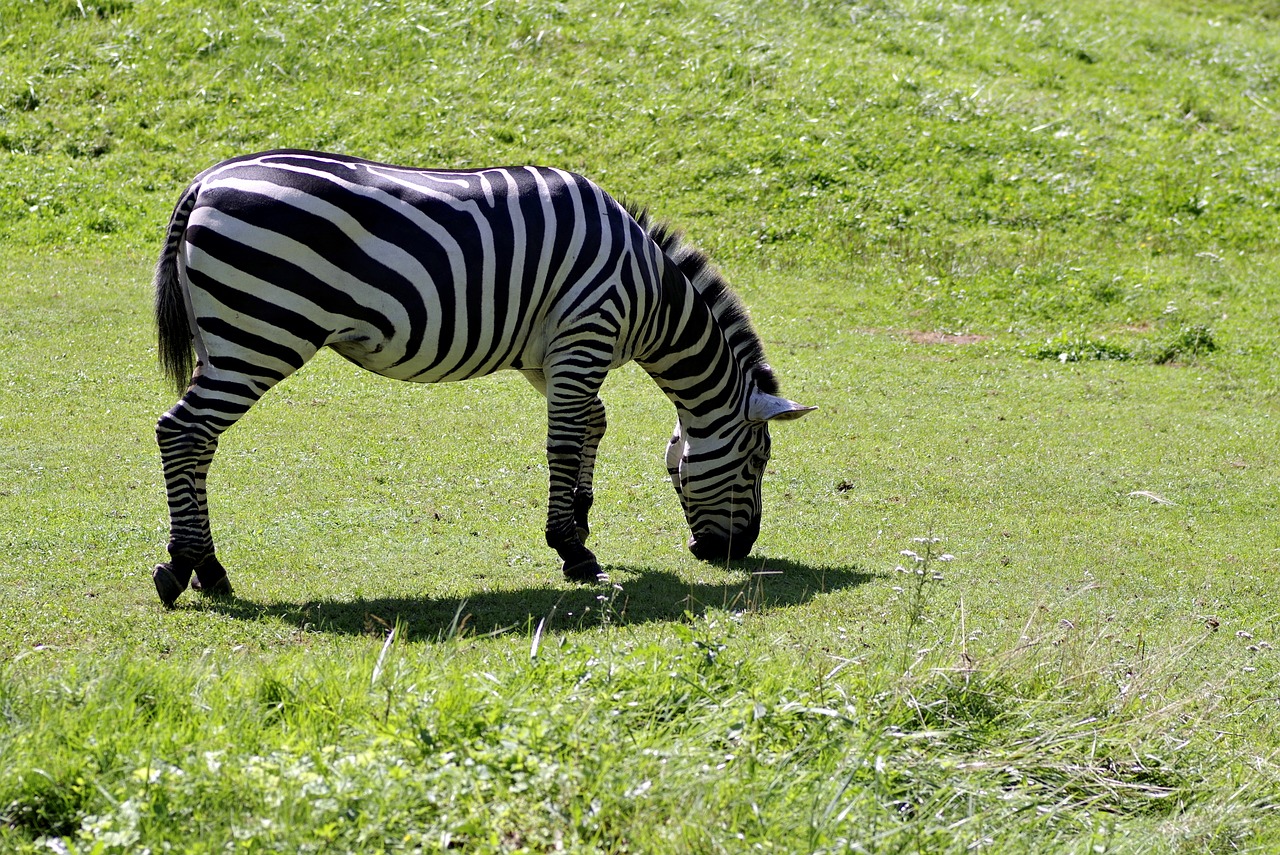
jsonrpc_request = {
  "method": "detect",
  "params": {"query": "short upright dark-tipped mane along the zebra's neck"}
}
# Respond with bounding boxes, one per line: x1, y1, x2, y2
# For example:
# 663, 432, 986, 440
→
623, 202, 780, 394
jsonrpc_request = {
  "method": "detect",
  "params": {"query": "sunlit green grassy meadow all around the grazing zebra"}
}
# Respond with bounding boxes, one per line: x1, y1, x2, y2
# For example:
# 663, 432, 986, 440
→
0, 0, 1280, 854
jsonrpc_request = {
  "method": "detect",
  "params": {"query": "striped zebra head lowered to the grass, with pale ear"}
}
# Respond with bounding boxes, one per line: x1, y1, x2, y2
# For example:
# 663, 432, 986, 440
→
667, 367, 817, 561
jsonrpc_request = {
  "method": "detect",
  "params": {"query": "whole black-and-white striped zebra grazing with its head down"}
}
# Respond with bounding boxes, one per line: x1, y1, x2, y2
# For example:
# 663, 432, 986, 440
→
154, 151, 812, 605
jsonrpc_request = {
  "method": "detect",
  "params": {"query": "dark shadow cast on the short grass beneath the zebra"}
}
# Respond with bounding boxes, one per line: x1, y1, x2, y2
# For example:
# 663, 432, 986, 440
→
202, 557, 874, 641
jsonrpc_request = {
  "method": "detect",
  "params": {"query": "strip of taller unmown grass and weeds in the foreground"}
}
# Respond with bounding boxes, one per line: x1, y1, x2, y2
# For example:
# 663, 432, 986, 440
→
0, 601, 1259, 852
